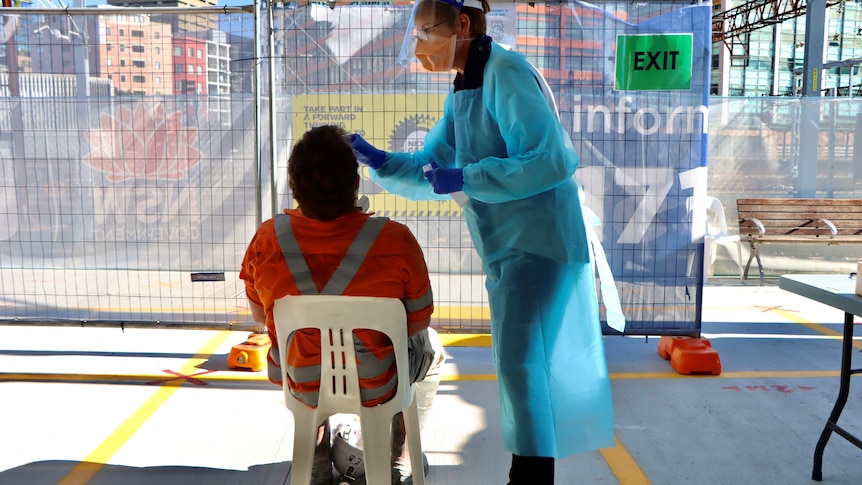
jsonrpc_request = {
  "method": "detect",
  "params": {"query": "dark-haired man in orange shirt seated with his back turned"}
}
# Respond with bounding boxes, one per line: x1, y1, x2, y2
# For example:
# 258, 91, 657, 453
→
239, 126, 443, 485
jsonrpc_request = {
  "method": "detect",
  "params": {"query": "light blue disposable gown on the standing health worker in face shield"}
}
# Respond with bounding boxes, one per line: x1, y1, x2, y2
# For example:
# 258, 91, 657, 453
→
373, 41, 614, 458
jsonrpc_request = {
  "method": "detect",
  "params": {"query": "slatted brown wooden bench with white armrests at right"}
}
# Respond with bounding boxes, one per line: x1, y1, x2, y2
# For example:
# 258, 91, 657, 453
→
736, 198, 862, 284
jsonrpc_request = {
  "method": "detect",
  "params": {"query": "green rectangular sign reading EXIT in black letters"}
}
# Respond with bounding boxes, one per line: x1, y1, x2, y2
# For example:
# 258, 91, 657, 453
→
614, 34, 693, 91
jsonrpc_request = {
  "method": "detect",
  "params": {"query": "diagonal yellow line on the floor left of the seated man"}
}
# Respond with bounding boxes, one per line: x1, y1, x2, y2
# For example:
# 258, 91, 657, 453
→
58, 331, 231, 485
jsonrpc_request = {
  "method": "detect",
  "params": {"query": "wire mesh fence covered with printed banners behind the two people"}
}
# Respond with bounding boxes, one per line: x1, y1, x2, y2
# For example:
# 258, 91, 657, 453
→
0, 2, 858, 334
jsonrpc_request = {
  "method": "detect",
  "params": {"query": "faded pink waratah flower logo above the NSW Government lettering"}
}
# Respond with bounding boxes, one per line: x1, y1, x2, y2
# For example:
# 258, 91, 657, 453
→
84, 103, 203, 182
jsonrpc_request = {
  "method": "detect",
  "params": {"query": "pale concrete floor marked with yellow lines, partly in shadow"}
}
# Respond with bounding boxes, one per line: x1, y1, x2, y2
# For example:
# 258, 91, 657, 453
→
0, 280, 862, 485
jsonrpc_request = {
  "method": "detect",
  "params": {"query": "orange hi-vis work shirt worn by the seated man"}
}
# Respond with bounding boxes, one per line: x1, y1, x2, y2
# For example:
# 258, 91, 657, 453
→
239, 209, 434, 406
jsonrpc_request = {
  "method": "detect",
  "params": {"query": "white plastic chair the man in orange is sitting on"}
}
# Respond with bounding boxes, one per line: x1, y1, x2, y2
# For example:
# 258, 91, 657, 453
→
273, 295, 425, 485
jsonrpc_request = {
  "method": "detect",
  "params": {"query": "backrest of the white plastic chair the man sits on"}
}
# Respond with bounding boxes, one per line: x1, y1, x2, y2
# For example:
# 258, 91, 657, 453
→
273, 295, 413, 417
